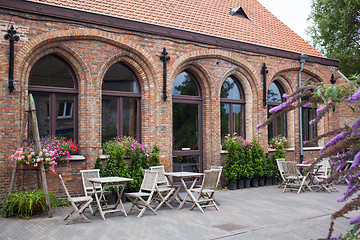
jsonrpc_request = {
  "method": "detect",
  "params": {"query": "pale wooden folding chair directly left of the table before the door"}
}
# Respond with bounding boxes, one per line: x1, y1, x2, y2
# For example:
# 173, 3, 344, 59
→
150, 166, 175, 211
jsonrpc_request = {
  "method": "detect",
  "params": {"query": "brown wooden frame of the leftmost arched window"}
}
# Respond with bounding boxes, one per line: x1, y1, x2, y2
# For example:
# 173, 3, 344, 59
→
28, 54, 78, 141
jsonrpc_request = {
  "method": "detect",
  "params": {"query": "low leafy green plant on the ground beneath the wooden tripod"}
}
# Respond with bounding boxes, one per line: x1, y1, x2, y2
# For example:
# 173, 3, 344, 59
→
1, 189, 58, 218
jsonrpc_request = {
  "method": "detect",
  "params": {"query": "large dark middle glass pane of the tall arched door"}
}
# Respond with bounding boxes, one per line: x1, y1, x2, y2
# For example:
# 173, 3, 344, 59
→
173, 103, 199, 150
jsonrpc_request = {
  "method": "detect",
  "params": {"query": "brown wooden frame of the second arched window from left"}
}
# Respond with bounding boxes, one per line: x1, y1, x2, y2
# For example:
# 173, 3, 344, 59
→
102, 62, 141, 141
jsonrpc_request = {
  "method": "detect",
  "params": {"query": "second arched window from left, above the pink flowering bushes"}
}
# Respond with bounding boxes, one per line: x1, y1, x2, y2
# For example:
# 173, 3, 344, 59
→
102, 63, 141, 142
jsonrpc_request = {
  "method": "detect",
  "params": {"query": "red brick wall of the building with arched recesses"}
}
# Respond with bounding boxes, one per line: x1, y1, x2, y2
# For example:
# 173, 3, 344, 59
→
0, 10, 351, 199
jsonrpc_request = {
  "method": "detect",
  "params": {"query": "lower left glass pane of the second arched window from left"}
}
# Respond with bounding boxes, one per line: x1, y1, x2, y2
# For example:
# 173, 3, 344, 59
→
101, 96, 118, 142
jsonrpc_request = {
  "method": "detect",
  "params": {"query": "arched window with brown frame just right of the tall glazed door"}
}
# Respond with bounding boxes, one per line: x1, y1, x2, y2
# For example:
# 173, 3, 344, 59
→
220, 77, 245, 138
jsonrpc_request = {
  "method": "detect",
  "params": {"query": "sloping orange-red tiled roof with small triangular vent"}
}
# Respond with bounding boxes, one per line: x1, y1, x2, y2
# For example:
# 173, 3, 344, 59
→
27, 0, 322, 57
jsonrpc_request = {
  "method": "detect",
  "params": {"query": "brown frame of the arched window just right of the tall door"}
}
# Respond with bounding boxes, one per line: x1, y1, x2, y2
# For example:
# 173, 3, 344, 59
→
220, 75, 246, 138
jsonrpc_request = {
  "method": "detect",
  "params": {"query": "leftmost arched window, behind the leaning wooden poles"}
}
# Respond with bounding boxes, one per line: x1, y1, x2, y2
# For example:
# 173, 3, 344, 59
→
29, 54, 78, 139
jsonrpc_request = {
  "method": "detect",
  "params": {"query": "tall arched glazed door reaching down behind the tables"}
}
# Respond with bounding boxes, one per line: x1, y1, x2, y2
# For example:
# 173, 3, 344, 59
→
172, 72, 202, 172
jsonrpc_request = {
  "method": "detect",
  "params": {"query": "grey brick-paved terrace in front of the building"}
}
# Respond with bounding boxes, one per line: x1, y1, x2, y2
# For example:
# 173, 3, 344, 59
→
0, 185, 349, 240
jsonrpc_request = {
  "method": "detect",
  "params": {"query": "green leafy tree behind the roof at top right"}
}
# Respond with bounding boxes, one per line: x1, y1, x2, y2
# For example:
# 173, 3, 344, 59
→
308, 0, 360, 77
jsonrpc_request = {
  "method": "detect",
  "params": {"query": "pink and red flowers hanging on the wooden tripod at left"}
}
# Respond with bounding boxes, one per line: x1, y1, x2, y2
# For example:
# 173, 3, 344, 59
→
11, 137, 78, 173
